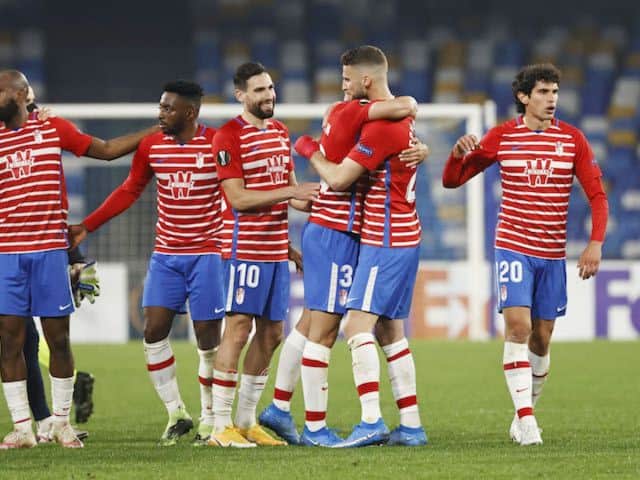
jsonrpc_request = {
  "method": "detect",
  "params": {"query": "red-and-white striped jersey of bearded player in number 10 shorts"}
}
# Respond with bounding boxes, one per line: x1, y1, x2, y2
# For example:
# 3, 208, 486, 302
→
213, 116, 293, 262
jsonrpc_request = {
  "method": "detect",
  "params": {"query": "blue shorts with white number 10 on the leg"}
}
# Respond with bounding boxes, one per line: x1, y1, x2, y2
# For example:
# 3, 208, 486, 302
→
224, 259, 289, 321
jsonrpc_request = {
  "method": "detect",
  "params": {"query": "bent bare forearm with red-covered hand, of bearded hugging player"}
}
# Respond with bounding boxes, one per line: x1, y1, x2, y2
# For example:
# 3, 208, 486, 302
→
294, 135, 367, 192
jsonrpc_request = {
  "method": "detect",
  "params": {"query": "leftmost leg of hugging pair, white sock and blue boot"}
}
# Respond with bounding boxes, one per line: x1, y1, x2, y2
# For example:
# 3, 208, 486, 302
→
258, 309, 311, 445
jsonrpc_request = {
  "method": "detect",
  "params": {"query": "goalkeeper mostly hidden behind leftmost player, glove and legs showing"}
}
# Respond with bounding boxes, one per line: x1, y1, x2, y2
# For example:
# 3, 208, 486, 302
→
24, 248, 100, 443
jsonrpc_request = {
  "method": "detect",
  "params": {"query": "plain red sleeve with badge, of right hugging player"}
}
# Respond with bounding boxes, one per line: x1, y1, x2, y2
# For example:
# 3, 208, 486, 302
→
348, 120, 404, 171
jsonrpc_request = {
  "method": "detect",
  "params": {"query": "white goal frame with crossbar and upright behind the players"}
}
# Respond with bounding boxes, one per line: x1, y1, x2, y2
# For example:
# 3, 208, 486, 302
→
52, 101, 496, 340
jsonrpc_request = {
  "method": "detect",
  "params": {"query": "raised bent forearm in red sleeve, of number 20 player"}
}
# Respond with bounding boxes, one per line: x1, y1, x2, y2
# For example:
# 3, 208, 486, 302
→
442, 135, 497, 188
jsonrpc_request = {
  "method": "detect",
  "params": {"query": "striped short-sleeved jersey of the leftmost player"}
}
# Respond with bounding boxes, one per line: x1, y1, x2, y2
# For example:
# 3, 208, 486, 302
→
0, 117, 92, 253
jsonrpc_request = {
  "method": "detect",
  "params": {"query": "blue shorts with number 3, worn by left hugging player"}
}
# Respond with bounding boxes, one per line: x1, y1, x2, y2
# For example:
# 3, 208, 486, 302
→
302, 223, 360, 315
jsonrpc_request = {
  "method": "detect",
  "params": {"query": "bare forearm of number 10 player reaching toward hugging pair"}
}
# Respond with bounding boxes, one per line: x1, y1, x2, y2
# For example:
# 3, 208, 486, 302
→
221, 178, 320, 212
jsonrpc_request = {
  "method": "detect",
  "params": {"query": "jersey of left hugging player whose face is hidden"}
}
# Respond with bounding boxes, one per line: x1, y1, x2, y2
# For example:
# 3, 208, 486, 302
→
309, 100, 372, 234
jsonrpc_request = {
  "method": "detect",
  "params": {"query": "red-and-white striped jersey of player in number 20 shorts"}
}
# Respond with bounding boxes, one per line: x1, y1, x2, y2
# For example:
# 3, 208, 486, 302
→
450, 117, 602, 259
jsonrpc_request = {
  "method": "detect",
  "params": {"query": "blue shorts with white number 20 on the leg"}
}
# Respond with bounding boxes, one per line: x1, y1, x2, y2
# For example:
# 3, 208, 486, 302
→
495, 248, 567, 320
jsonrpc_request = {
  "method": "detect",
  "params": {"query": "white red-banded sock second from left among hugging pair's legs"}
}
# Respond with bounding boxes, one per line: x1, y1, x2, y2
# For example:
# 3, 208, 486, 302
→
302, 341, 331, 432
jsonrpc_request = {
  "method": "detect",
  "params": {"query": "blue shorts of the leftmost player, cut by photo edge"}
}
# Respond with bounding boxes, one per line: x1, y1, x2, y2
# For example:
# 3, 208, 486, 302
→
0, 250, 74, 317
